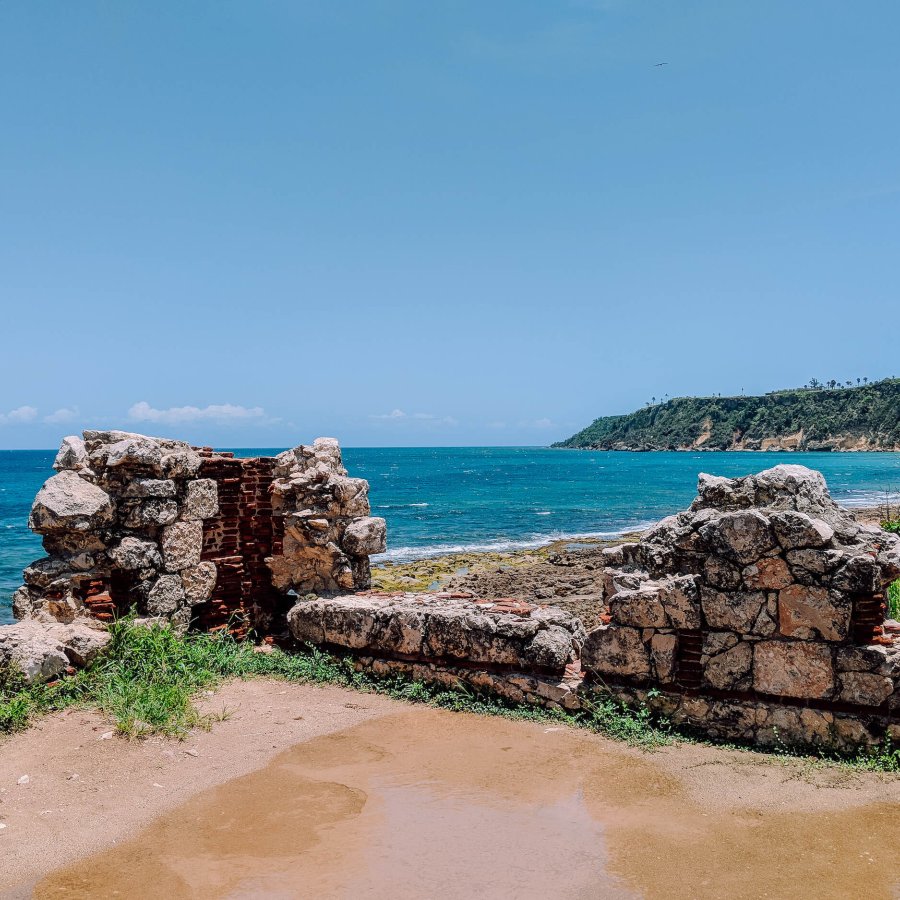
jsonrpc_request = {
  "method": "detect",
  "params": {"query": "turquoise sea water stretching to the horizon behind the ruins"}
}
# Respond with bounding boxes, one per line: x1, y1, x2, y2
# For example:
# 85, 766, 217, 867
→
0, 447, 900, 621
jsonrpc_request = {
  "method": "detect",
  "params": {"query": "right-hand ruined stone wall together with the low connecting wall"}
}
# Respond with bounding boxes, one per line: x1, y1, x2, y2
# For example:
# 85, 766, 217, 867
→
272, 466, 900, 750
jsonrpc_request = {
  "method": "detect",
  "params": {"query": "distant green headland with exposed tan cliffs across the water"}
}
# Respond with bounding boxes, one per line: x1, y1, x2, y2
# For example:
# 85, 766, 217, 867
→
553, 378, 900, 451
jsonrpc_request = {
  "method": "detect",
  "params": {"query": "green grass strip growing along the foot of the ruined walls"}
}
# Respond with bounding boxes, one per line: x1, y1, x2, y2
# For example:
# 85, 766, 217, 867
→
0, 619, 900, 772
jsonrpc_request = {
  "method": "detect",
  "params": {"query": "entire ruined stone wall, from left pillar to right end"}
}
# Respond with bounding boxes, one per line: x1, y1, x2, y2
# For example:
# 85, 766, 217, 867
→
0, 440, 900, 750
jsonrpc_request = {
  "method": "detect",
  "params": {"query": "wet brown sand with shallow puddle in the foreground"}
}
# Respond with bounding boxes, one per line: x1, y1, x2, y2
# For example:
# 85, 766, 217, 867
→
0, 687, 900, 898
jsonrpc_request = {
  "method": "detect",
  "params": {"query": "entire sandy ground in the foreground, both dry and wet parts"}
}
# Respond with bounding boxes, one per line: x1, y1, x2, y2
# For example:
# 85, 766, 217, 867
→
0, 680, 900, 898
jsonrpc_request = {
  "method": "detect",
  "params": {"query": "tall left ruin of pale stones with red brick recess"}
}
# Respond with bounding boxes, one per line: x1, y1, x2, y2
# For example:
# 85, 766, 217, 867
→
0, 431, 385, 677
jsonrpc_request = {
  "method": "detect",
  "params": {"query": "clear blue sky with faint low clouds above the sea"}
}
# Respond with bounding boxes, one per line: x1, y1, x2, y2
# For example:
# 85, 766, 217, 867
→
0, 0, 900, 447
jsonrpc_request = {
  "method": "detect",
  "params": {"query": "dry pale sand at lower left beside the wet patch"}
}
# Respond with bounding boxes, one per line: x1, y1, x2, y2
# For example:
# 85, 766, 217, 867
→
0, 679, 393, 896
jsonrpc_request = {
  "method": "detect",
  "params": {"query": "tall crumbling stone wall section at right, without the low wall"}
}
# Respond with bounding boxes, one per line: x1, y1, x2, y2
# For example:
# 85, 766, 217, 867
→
582, 466, 900, 746
